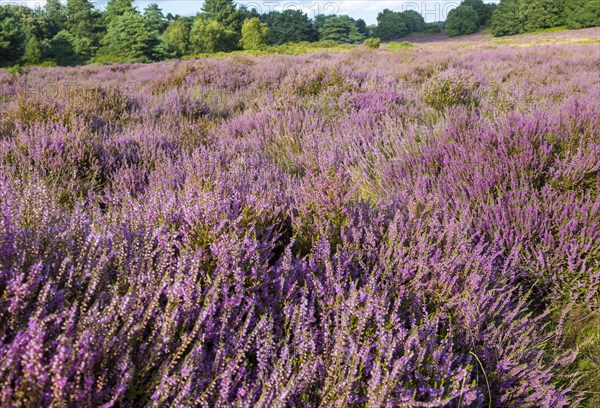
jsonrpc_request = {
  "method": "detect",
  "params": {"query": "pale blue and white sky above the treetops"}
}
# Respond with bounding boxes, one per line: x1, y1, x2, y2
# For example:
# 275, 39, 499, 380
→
0, 0, 499, 24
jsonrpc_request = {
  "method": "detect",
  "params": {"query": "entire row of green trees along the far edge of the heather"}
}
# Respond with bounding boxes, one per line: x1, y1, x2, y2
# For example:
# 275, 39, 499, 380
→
0, 0, 600, 66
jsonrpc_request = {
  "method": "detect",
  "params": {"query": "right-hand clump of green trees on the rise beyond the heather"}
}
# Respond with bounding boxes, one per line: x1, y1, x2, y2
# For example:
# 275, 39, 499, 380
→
445, 0, 600, 36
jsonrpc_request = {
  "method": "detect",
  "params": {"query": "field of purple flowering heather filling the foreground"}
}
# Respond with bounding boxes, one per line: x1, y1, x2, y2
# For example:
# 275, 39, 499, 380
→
0, 29, 600, 407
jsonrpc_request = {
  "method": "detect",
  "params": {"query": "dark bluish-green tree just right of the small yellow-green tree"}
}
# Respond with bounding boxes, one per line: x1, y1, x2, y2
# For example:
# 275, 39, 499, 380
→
261, 10, 319, 45
